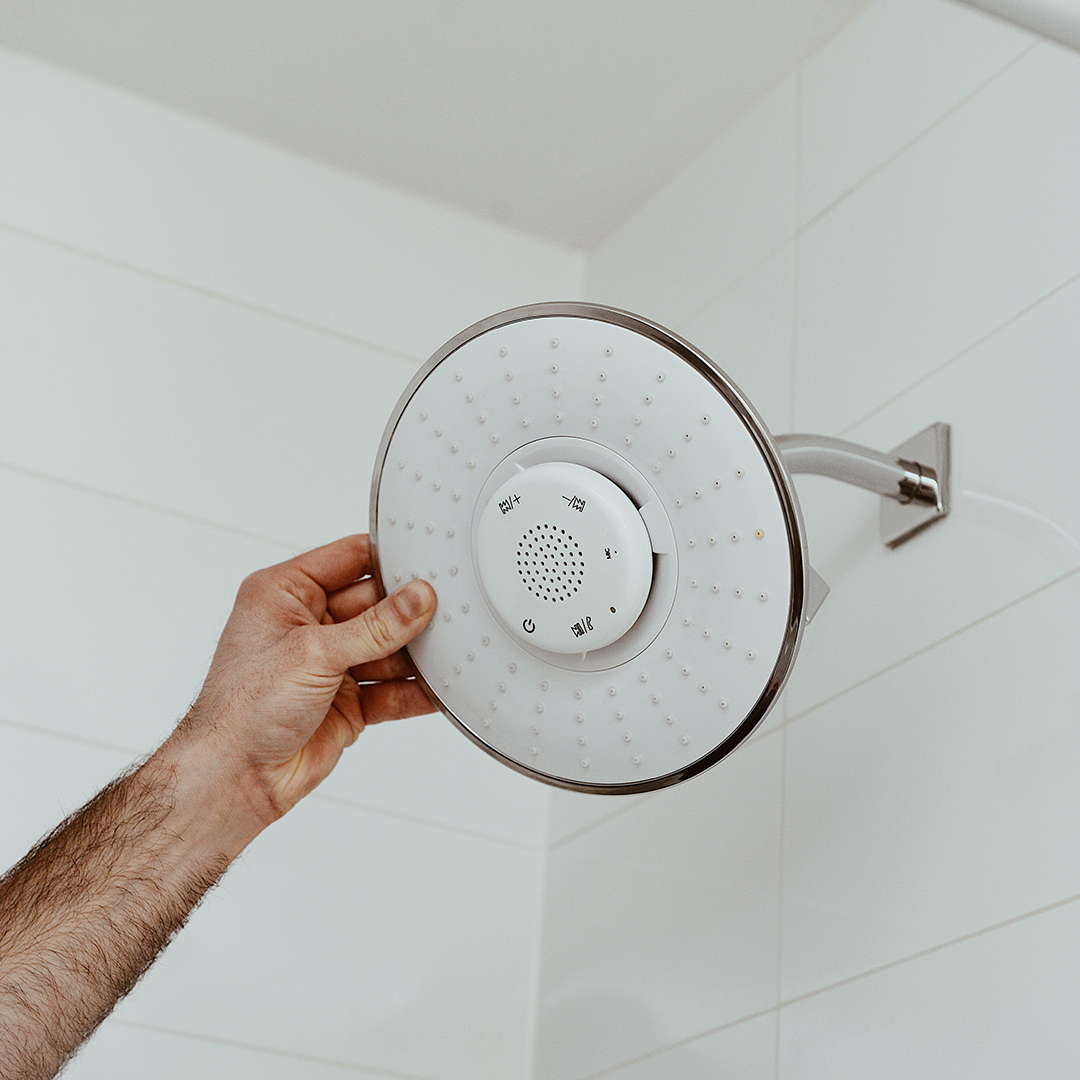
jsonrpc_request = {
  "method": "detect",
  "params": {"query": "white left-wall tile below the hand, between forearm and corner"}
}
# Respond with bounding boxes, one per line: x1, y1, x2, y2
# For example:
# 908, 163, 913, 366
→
118, 799, 541, 1080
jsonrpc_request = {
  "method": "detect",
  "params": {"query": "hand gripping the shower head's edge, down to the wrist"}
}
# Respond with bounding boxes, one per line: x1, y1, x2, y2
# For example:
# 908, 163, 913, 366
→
178, 536, 436, 820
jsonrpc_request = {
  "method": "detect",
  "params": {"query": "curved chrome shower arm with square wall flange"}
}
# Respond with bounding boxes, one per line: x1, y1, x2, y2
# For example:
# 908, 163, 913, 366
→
777, 423, 950, 548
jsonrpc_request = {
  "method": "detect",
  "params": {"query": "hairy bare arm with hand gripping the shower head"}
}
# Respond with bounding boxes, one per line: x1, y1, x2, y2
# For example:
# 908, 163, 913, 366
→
0, 537, 435, 1080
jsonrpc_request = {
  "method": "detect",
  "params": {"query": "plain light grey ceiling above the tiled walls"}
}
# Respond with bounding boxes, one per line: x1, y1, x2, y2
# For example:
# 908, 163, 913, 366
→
0, 0, 869, 248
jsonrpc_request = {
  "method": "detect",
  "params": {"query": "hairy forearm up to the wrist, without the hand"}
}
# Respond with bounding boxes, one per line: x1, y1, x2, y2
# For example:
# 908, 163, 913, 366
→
0, 727, 269, 1080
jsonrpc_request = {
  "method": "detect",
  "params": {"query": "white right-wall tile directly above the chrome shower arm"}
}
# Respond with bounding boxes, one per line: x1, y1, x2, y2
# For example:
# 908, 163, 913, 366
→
795, 39, 1080, 434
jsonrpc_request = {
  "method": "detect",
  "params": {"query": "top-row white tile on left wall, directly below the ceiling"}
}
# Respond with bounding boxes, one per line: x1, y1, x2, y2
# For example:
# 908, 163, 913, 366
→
0, 50, 581, 361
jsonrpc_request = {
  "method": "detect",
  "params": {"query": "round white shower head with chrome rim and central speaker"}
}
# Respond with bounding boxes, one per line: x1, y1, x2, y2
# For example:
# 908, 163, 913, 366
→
372, 305, 806, 794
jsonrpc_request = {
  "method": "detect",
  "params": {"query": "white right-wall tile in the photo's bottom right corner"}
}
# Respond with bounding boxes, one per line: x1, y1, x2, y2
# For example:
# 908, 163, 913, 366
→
780, 903, 1080, 1080
